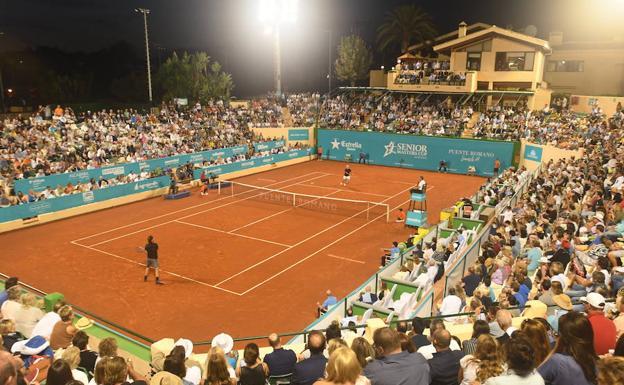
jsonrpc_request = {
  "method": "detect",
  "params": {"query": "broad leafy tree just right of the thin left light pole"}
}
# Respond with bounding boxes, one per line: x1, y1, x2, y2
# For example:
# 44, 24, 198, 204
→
156, 52, 234, 103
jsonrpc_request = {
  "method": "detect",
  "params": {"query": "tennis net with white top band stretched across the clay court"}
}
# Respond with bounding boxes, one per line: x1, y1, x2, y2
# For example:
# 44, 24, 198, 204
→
218, 181, 390, 222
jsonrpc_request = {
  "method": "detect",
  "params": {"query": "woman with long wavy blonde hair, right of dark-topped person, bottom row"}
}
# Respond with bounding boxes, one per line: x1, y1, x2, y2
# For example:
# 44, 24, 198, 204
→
459, 334, 505, 385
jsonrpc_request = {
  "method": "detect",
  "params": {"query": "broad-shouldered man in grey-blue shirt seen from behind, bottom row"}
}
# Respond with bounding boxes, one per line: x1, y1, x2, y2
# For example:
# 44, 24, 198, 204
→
364, 327, 430, 385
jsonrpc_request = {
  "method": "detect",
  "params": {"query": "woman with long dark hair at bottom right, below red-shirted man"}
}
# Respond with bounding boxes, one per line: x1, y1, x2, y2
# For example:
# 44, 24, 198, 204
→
537, 311, 598, 385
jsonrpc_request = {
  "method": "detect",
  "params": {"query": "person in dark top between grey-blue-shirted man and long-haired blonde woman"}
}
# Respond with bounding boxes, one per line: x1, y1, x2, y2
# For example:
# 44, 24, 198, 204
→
429, 329, 464, 385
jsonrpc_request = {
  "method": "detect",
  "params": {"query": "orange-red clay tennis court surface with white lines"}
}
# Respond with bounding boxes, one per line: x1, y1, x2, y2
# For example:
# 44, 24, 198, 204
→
0, 161, 484, 341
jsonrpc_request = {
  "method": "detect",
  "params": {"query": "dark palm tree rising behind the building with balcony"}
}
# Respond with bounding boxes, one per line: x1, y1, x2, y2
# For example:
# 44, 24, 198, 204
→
377, 4, 436, 53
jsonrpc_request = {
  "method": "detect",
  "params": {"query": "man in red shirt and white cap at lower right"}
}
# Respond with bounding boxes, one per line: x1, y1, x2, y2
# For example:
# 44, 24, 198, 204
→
581, 293, 617, 355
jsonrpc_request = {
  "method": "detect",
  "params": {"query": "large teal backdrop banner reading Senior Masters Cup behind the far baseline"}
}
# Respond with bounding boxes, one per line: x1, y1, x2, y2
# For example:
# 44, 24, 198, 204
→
318, 129, 514, 176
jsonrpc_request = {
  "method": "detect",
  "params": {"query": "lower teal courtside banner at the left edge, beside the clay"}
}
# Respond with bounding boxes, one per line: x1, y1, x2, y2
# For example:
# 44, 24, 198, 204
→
0, 176, 170, 222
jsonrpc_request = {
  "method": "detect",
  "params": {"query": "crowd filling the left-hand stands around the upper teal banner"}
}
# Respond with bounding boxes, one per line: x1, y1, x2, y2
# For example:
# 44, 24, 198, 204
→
0, 98, 294, 207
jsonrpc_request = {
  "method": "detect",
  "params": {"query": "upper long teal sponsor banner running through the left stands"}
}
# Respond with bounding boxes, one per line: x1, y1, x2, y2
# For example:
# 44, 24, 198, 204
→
15, 141, 249, 194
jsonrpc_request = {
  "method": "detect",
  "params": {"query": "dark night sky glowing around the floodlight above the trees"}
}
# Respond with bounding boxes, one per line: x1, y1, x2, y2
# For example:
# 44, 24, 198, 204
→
0, 0, 624, 96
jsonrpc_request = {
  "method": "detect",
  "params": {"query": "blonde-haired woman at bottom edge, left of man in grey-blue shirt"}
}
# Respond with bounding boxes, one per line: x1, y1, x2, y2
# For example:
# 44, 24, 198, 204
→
314, 347, 370, 385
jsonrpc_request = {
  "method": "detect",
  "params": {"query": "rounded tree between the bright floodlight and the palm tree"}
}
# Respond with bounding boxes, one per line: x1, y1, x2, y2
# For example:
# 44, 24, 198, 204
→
336, 35, 373, 86
